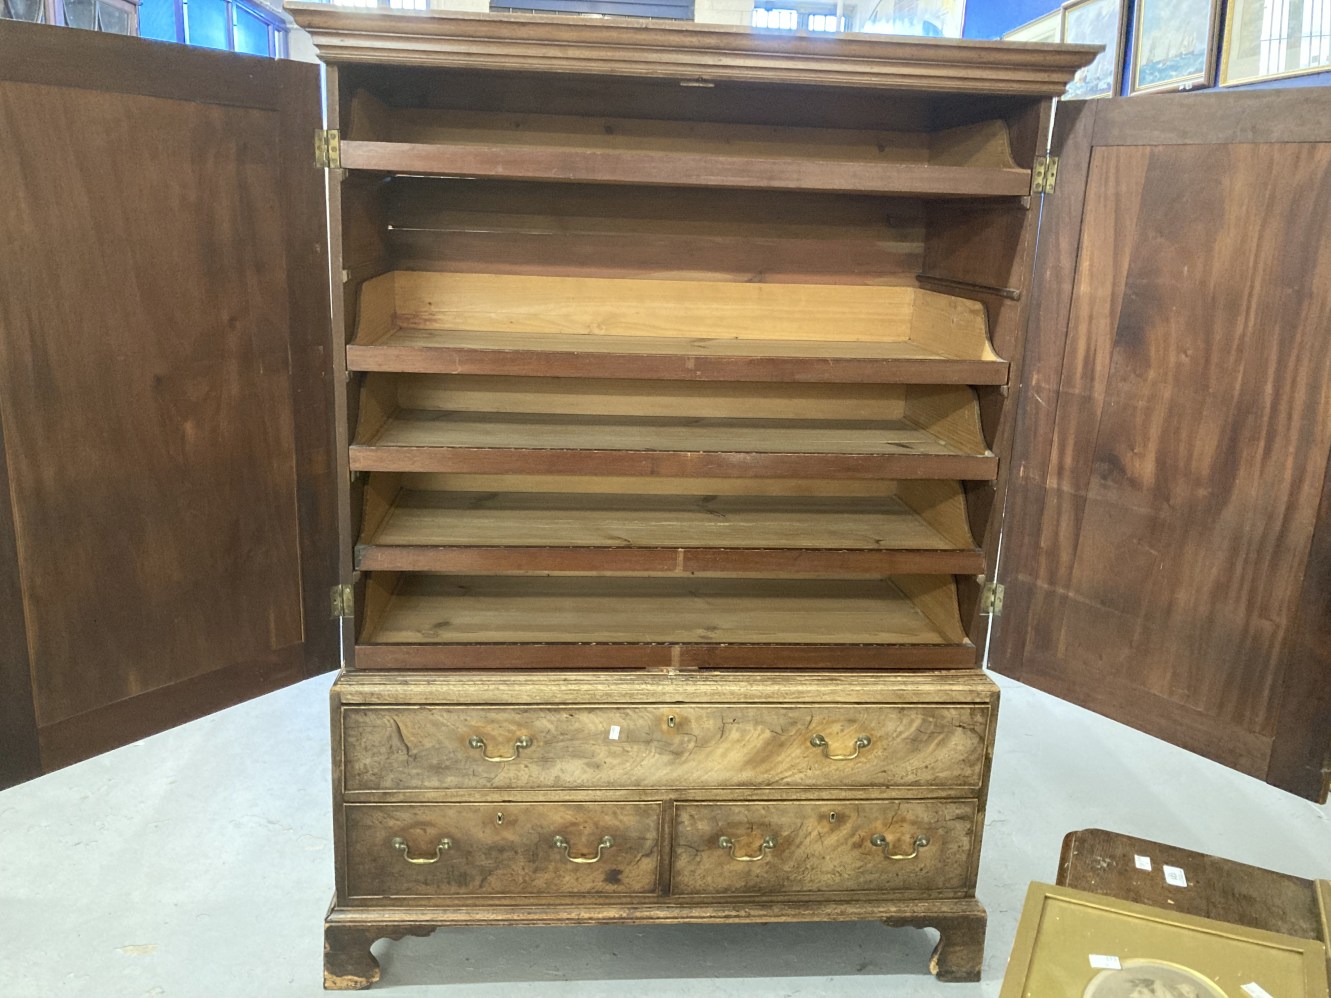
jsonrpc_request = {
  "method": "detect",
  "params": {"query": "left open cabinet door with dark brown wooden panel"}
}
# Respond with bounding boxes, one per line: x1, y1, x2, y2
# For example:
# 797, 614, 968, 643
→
0, 21, 338, 785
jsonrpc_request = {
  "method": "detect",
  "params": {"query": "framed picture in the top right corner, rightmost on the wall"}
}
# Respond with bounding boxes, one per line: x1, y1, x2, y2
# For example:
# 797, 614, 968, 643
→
1221, 0, 1331, 86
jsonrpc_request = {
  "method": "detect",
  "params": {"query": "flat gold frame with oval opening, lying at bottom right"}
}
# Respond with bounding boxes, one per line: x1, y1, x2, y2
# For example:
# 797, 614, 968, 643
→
998, 884, 1327, 998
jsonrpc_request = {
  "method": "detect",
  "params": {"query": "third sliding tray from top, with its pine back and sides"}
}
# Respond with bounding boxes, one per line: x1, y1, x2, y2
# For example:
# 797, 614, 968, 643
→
350, 374, 998, 480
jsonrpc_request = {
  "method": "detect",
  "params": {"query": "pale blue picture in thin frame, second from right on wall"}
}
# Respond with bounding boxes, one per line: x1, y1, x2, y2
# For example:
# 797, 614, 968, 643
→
1129, 0, 1219, 93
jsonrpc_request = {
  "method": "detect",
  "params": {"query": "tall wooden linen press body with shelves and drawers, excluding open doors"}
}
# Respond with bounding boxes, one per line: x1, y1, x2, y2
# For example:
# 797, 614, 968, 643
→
291, 5, 1090, 987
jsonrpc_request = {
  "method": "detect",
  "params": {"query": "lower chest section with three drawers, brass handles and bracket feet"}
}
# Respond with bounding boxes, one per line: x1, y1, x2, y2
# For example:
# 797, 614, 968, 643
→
326, 669, 998, 987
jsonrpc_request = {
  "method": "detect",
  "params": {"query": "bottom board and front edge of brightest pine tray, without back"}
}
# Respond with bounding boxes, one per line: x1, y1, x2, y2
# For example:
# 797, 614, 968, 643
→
346, 329, 1008, 385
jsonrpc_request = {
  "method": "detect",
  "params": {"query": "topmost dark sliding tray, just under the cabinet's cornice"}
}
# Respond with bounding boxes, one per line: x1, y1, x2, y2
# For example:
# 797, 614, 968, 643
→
339, 98, 1030, 198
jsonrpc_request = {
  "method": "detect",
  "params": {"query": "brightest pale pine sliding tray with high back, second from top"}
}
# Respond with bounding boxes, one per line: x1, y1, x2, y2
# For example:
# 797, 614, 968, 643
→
346, 271, 1008, 385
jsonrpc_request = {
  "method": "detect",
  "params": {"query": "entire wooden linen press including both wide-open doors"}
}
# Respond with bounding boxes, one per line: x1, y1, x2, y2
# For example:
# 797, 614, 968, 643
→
0, 4, 1331, 987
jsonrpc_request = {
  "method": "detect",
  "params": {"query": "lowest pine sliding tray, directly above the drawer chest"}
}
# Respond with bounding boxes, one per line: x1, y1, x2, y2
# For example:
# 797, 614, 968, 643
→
357, 575, 976, 668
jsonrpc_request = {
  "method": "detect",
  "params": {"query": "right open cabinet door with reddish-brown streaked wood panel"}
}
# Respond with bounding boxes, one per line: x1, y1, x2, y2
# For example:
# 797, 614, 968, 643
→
992, 88, 1331, 798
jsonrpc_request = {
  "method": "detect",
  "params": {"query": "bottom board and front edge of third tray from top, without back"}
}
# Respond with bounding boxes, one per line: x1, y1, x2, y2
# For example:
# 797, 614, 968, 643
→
350, 410, 998, 480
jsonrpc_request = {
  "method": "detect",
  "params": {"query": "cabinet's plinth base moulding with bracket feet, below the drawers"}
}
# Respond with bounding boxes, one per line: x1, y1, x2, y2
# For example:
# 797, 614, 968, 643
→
323, 898, 986, 991
